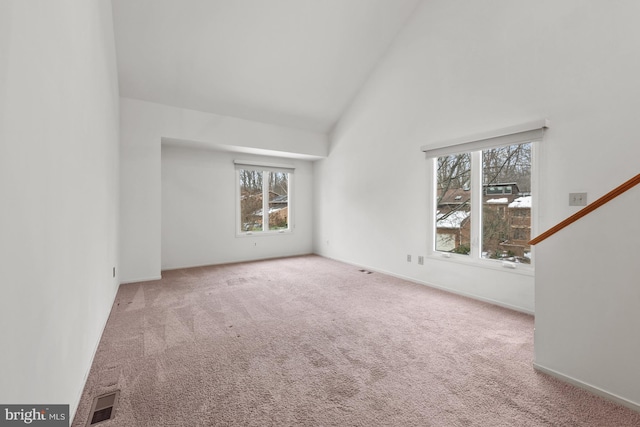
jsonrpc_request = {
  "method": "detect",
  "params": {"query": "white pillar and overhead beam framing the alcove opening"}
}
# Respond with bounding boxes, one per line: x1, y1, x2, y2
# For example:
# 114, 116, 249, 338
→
120, 98, 327, 282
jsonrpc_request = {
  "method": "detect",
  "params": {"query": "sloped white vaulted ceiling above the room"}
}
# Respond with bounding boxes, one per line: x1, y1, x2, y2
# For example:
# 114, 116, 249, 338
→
112, 0, 420, 132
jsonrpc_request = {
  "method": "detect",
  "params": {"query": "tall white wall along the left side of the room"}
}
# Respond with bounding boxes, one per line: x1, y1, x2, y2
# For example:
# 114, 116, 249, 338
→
0, 0, 118, 422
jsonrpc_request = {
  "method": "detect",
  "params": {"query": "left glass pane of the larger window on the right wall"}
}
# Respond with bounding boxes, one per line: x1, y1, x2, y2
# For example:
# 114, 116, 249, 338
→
435, 153, 471, 255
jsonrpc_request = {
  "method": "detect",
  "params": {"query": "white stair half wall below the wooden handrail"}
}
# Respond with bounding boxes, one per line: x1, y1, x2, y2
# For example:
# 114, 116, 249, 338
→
535, 186, 640, 410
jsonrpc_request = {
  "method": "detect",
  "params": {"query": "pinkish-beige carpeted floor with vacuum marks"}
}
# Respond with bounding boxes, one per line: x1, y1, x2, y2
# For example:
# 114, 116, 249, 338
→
73, 256, 640, 427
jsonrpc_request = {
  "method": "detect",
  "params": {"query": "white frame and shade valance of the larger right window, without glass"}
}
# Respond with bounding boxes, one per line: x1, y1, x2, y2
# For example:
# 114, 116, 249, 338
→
421, 119, 550, 275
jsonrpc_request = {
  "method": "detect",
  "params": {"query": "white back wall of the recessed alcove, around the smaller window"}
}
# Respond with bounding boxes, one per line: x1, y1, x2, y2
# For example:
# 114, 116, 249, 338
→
162, 144, 313, 270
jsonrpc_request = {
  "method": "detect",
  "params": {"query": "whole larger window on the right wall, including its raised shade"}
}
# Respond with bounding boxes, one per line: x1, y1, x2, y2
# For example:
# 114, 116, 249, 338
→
423, 121, 547, 265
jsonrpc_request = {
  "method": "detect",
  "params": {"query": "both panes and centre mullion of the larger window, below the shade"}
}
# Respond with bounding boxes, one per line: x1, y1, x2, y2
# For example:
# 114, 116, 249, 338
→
435, 142, 532, 264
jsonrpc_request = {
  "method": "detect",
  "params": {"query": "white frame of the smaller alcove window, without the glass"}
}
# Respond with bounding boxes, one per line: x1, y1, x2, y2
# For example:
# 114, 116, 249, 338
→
233, 160, 295, 237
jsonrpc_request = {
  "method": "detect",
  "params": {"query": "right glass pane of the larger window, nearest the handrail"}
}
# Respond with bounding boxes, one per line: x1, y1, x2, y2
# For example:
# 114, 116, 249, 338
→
482, 143, 531, 264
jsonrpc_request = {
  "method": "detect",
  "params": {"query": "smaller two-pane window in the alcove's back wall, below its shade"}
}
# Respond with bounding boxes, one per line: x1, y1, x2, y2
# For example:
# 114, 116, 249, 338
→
236, 161, 293, 234
